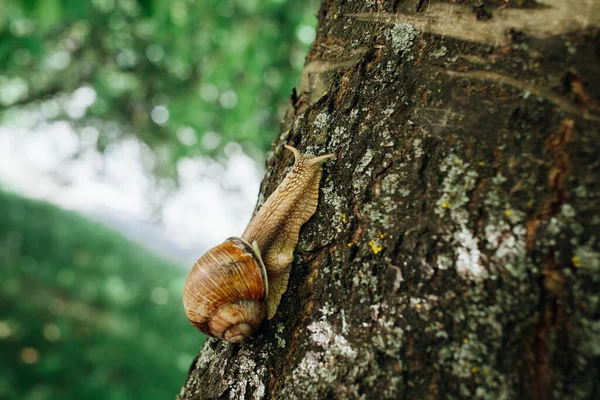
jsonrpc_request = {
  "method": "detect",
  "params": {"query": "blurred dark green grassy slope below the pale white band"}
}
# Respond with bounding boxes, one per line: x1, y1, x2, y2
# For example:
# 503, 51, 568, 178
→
0, 191, 203, 400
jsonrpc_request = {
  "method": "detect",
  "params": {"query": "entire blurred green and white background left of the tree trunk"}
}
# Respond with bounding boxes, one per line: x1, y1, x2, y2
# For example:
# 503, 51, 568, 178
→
0, 0, 318, 400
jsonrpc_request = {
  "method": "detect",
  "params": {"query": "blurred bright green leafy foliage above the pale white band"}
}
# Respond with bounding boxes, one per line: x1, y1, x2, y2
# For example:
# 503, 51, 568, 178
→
0, 0, 317, 176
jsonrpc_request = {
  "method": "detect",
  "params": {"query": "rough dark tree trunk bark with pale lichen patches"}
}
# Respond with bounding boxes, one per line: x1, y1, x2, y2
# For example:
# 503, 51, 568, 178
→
180, 0, 600, 399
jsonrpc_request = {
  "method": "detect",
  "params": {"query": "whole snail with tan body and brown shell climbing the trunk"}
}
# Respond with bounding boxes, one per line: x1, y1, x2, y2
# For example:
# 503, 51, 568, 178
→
183, 145, 335, 343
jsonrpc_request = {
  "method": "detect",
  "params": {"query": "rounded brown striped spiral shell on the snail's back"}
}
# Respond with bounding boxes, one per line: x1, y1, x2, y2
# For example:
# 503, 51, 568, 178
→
183, 237, 268, 343
